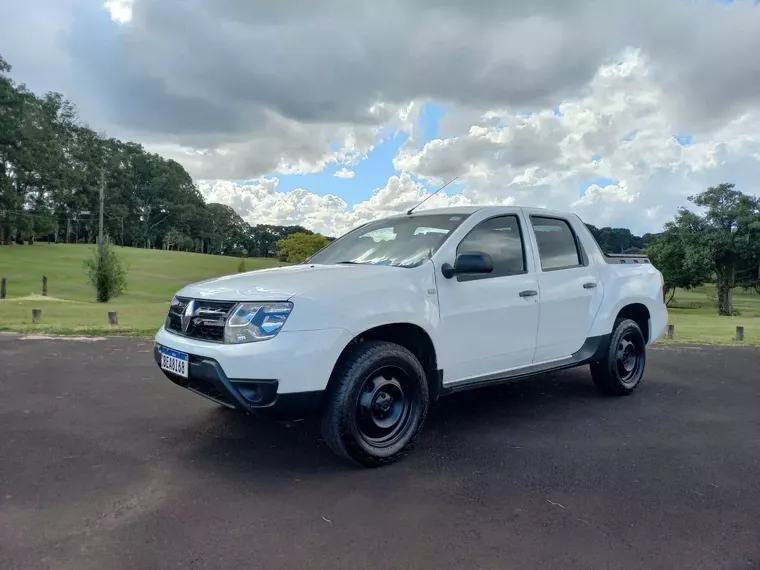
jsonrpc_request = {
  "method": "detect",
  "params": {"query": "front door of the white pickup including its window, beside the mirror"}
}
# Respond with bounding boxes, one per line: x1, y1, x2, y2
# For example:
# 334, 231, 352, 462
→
436, 214, 539, 385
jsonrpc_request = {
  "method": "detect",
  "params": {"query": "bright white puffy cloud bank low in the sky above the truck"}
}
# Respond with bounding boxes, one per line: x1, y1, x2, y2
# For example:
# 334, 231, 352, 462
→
203, 50, 760, 234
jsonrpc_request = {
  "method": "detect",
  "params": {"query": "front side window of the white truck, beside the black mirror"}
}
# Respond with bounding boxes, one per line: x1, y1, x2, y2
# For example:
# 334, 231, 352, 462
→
457, 215, 525, 281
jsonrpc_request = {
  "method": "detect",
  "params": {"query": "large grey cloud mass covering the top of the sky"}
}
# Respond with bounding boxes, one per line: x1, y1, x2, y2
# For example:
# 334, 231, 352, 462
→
0, 0, 760, 191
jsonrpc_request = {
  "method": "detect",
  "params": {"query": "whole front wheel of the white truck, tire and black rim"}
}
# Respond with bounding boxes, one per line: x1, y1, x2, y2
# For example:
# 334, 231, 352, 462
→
320, 341, 429, 467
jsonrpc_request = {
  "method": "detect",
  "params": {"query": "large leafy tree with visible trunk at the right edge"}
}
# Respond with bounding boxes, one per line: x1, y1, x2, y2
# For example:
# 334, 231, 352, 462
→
655, 183, 760, 316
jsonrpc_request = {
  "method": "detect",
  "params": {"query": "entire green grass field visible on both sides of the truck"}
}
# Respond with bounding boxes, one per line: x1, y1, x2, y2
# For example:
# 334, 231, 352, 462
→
0, 244, 760, 345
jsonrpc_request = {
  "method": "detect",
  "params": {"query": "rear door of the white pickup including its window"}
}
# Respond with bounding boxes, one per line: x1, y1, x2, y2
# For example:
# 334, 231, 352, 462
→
527, 214, 601, 364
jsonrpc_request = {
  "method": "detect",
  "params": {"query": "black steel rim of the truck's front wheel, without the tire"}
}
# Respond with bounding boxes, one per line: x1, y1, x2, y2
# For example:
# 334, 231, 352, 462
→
354, 366, 418, 448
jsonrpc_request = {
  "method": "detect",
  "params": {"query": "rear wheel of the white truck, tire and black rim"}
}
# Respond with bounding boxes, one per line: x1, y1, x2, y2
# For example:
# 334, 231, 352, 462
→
590, 319, 646, 396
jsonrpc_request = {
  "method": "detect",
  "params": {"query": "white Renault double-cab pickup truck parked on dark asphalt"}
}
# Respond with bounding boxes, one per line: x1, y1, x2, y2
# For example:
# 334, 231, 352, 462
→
155, 206, 668, 467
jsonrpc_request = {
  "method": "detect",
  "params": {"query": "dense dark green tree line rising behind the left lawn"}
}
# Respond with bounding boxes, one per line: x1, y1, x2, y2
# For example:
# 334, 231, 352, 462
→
0, 56, 330, 257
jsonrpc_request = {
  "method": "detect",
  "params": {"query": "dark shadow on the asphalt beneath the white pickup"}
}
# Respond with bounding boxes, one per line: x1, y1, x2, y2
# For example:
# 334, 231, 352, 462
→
177, 368, 604, 478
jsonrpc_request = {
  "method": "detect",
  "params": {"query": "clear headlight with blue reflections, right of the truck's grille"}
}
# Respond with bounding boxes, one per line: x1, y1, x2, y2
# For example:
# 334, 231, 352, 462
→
224, 303, 293, 344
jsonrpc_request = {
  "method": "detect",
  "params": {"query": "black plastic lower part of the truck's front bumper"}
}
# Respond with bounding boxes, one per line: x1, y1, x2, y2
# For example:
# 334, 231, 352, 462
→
153, 343, 324, 420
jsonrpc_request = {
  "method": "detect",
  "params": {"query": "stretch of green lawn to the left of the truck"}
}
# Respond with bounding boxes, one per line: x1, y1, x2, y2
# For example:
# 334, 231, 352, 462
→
0, 244, 283, 335
